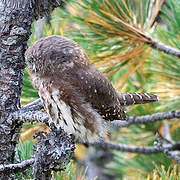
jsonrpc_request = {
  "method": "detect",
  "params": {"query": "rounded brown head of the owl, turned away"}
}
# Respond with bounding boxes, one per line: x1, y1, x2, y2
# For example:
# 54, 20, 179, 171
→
25, 35, 89, 76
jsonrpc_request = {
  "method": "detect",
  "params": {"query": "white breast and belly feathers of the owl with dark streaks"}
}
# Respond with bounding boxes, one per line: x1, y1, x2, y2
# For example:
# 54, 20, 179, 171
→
33, 75, 107, 142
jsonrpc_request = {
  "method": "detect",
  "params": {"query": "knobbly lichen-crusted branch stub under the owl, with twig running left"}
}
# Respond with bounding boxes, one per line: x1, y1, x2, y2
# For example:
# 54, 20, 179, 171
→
0, 123, 75, 175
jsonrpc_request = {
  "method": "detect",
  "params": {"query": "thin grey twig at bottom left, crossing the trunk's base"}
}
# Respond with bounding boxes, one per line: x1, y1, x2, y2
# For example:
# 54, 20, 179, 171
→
0, 158, 35, 173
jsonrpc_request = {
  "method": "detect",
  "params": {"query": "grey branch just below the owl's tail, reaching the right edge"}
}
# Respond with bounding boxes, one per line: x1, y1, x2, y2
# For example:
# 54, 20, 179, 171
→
111, 110, 180, 127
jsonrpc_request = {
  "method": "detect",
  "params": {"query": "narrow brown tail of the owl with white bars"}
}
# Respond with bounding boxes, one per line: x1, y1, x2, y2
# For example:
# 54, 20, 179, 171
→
119, 93, 158, 106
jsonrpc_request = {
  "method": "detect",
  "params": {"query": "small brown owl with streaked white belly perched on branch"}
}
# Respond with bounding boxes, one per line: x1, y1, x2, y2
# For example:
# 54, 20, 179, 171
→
25, 36, 157, 142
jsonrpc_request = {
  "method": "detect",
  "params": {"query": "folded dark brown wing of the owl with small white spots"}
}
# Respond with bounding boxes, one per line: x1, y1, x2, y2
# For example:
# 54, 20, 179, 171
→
68, 65, 126, 121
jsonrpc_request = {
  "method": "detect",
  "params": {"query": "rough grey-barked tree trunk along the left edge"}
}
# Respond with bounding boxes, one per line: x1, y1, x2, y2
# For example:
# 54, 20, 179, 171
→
0, 0, 33, 179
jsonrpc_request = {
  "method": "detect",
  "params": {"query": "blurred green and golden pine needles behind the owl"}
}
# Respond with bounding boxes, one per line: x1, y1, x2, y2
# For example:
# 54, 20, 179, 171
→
16, 0, 180, 180
